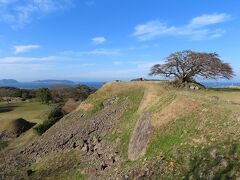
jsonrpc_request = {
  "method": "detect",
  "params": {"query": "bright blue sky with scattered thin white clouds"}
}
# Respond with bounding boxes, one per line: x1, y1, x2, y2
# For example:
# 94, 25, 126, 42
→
0, 0, 240, 81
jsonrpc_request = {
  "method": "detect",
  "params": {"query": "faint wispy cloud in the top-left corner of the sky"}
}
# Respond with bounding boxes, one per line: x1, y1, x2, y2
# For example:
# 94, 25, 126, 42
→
0, 0, 73, 28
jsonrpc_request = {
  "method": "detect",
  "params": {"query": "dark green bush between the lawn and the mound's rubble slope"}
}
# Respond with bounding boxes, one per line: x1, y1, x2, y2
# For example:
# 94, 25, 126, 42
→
34, 107, 63, 135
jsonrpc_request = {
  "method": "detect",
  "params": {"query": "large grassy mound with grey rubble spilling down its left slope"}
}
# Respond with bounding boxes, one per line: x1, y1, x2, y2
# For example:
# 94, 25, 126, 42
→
0, 82, 240, 179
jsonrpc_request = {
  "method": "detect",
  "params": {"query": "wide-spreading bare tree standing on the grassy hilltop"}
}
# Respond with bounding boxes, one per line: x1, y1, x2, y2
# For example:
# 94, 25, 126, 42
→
149, 50, 234, 85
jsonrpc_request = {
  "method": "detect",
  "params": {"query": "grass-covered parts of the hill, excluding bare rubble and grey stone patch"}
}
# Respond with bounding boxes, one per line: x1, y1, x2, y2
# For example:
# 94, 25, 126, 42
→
2, 82, 240, 179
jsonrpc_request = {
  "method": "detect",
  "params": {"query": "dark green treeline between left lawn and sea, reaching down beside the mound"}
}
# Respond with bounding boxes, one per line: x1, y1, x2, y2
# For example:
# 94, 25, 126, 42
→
0, 85, 96, 135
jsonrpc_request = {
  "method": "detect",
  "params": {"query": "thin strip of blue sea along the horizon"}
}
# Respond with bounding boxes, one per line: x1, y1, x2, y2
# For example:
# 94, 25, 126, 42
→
0, 81, 240, 89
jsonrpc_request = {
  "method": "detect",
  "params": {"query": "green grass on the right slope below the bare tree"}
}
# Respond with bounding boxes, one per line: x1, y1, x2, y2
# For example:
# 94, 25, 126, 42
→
143, 87, 240, 179
